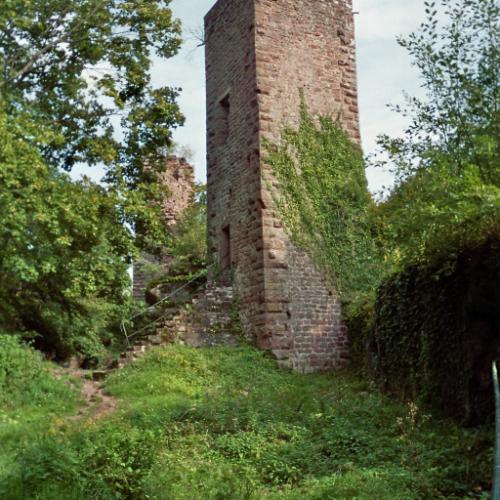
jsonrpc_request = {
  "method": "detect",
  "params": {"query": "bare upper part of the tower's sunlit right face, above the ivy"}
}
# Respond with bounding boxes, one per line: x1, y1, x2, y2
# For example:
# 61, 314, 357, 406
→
254, 0, 360, 139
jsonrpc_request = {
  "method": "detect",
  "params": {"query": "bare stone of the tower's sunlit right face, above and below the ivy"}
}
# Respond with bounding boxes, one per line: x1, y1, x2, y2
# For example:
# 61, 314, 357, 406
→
255, 0, 359, 371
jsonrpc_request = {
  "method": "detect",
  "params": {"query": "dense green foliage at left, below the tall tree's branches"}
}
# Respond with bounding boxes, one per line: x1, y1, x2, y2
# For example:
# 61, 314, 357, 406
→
0, 106, 135, 358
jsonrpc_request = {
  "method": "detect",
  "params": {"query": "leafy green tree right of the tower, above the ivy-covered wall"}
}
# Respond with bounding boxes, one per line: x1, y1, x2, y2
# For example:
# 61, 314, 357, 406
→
380, 0, 500, 267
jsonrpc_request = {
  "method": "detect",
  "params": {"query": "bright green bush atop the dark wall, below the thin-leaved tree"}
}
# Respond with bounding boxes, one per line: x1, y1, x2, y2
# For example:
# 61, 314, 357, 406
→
378, 165, 500, 270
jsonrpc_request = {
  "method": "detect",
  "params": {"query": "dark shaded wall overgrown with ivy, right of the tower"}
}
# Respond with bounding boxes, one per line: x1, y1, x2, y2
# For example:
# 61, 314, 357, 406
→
349, 240, 500, 424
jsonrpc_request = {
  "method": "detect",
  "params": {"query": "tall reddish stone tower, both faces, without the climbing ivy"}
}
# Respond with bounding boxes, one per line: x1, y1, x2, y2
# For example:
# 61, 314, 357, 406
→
205, 0, 359, 372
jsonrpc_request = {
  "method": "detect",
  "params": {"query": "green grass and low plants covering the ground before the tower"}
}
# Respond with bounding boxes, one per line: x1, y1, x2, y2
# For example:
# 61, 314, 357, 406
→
0, 346, 493, 500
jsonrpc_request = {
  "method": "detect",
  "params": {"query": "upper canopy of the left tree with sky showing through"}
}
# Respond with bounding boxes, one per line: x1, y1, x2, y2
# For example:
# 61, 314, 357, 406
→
0, 0, 183, 188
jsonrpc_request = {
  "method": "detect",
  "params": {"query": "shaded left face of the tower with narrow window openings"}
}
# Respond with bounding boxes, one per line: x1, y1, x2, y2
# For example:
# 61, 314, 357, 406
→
205, 0, 264, 337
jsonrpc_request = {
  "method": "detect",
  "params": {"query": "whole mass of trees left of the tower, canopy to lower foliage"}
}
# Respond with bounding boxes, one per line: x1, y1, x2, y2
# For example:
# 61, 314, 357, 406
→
0, 0, 189, 358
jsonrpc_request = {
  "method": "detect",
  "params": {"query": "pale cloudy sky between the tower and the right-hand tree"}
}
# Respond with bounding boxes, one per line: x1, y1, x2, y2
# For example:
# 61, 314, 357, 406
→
354, 0, 424, 191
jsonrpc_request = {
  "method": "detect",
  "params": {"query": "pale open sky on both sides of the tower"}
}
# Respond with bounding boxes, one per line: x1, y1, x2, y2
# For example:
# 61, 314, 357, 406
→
152, 0, 424, 192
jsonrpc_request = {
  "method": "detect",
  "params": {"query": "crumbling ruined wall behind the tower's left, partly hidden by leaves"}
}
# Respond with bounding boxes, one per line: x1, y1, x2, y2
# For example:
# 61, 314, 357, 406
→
133, 156, 195, 300
